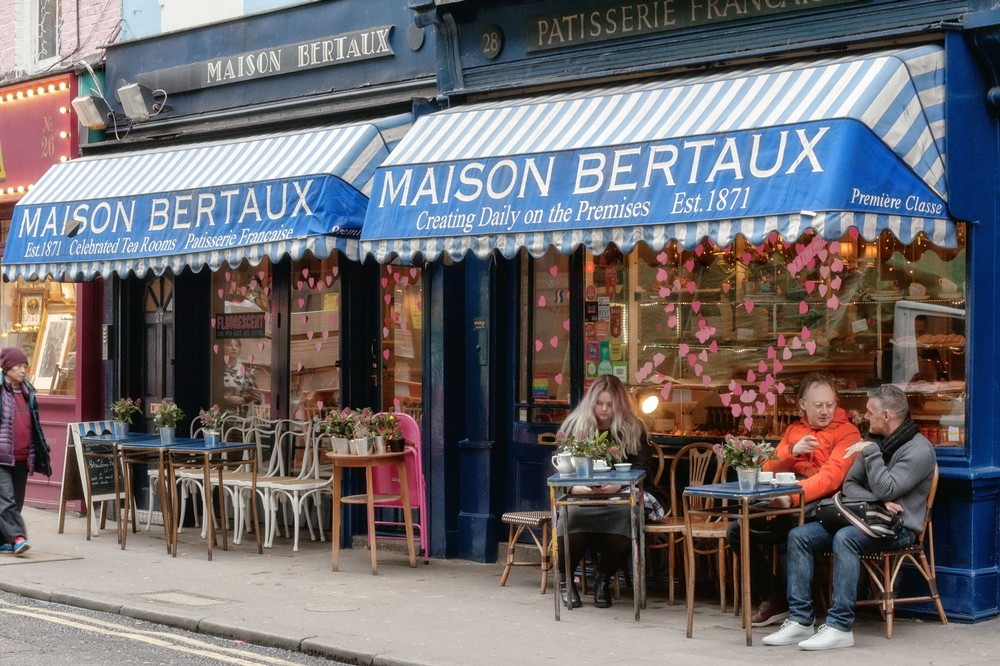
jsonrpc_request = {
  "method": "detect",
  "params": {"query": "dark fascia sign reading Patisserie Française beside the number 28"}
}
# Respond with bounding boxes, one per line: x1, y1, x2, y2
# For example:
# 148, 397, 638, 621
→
526, 0, 856, 51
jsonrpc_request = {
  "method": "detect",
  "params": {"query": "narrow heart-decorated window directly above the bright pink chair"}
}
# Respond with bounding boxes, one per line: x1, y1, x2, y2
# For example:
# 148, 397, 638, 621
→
380, 265, 424, 421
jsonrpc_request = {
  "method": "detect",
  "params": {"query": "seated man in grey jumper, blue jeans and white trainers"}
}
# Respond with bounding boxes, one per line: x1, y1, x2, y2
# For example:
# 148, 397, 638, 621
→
764, 384, 936, 650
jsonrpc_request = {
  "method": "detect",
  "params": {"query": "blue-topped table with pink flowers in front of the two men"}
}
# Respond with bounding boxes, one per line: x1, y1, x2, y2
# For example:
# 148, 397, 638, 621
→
683, 482, 805, 646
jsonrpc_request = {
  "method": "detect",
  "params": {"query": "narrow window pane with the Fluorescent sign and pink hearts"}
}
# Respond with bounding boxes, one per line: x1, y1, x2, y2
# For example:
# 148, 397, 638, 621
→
212, 259, 272, 416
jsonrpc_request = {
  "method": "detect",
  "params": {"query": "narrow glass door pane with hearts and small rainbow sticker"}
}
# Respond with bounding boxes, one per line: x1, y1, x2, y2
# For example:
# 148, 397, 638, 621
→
518, 249, 572, 423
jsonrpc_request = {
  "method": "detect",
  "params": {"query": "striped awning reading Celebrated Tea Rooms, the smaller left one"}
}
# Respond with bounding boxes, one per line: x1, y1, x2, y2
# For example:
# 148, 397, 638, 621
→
2, 114, 412, 280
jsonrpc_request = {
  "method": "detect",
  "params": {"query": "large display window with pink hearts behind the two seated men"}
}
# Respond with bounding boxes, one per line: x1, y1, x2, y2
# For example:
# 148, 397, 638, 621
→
628, 230, 967, 445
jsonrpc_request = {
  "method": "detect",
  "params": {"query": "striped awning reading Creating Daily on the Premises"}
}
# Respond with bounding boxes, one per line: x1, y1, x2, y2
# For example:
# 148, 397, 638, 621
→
361, 46, 956, 262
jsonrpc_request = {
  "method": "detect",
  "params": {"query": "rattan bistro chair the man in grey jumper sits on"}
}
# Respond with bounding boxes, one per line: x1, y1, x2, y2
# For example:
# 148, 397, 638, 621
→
856, 465, 948, 638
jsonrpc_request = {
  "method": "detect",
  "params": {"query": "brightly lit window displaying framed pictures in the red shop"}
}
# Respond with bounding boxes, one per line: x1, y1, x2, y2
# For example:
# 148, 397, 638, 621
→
0, 279, 76, 395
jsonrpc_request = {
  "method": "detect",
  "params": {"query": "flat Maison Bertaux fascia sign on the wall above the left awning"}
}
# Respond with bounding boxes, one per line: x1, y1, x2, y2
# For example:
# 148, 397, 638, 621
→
138, 25, 395, 92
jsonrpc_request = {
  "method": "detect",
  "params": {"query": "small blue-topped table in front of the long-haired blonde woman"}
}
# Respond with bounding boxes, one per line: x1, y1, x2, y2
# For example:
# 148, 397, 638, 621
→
547, 469, 646, 622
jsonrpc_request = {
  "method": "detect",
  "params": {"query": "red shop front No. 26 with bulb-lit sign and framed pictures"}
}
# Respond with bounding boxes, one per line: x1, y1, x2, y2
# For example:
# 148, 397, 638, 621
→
0, 74, 102, 508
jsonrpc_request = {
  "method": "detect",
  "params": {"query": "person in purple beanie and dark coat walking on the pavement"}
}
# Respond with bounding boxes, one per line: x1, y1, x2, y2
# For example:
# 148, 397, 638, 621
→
0, 347, 52, 555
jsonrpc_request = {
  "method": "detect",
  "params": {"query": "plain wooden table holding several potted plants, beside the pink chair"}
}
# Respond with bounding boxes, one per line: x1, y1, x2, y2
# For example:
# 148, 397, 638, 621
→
326, 451, 417, 576
